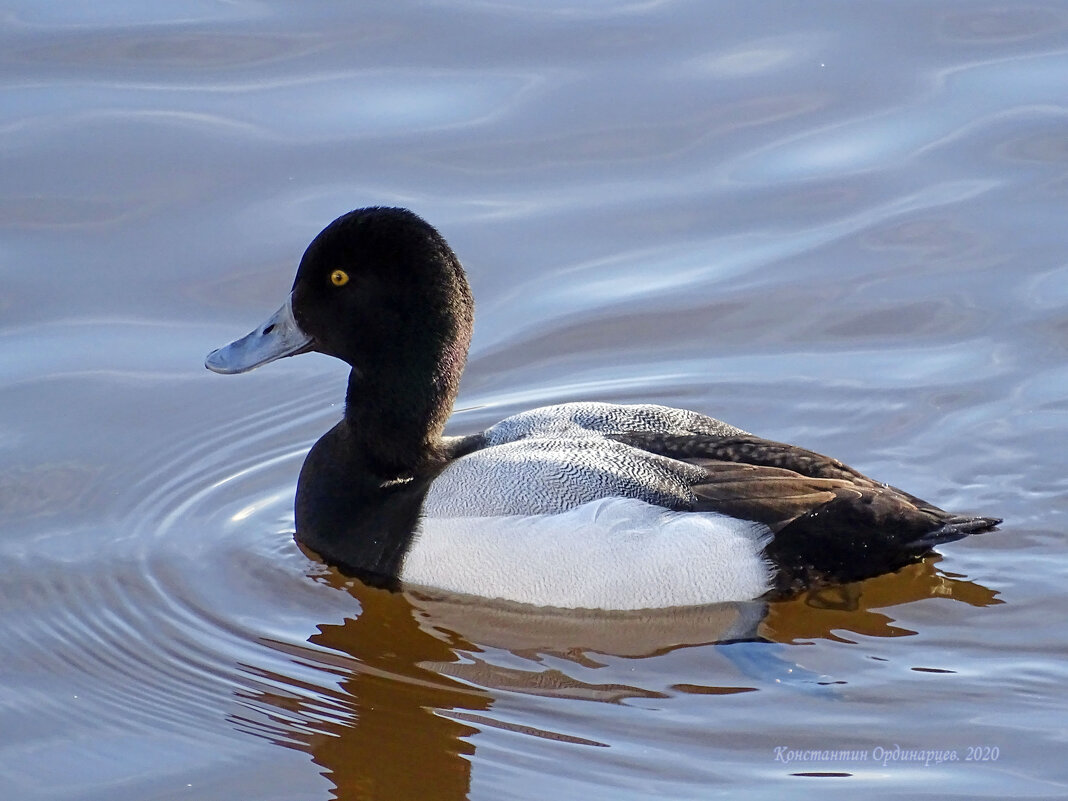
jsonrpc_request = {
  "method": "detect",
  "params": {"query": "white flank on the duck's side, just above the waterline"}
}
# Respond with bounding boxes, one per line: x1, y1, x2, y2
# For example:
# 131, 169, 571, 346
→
401, 498, 771, 610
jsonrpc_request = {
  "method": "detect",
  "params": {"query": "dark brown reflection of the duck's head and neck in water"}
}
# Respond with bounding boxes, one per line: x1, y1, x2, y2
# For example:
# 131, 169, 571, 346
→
238, 586, 491, 799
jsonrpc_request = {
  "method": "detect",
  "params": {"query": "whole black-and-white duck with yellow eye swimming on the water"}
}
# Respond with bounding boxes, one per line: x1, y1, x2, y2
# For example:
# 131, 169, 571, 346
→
205, 206, 1002, 610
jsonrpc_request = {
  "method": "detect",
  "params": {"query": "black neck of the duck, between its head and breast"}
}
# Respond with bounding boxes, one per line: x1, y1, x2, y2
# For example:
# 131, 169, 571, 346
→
345, 341, 467, 482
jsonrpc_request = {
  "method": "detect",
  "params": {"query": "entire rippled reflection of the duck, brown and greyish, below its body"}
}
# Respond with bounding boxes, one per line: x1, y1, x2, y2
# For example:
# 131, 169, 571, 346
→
233, 557, 1002, 800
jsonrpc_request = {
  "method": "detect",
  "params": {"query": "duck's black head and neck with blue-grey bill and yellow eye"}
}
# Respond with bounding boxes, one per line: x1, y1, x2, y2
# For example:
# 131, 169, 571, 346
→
206, 207, 474, 471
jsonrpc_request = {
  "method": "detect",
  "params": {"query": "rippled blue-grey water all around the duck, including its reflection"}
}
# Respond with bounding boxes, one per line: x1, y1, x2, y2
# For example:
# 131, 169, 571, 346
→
0, 0, 1068, 801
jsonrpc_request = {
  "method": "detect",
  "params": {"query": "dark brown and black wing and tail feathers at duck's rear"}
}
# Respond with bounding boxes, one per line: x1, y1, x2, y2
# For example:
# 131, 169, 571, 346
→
613, 433, 1001, 593
